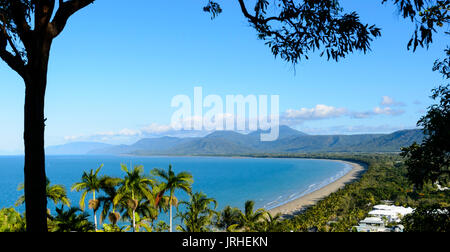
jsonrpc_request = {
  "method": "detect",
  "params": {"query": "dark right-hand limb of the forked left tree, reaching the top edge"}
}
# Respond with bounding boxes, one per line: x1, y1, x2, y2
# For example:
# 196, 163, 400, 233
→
51, 0, 95, 37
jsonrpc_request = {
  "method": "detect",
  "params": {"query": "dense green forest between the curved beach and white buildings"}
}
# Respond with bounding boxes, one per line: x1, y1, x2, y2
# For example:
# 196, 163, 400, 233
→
272, 154, 450, 232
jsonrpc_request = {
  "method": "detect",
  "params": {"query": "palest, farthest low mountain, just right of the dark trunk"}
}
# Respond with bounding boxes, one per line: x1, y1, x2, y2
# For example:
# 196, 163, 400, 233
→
45, 142, 112, 155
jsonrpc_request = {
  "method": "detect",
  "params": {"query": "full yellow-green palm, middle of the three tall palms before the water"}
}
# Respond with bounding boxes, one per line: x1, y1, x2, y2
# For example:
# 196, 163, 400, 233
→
113, 164, 154, 232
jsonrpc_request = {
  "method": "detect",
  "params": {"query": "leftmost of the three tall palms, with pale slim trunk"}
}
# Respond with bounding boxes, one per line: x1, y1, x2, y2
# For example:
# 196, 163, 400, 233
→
72, 164, 103, 231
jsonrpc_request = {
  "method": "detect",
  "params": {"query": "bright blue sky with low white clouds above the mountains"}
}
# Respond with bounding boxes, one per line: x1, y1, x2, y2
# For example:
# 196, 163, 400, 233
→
0, 0, 448, 153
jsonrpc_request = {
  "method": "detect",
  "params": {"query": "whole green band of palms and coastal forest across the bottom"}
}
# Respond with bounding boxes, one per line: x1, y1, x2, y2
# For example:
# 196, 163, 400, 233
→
0, 153, 450, 232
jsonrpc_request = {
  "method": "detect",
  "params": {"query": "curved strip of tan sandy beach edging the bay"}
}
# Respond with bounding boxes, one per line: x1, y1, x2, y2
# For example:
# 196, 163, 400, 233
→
269, 160, 366, 217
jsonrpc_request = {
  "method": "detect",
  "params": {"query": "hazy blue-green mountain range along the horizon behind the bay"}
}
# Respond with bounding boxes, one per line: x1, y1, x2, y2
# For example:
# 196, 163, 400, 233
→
46, 126, 424, 156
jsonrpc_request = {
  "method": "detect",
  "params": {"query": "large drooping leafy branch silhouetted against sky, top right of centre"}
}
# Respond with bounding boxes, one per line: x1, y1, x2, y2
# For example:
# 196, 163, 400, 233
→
204, 0, 381, 64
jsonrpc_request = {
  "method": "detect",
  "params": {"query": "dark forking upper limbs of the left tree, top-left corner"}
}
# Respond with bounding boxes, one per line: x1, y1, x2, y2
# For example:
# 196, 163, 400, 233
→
0, 0, 94, 79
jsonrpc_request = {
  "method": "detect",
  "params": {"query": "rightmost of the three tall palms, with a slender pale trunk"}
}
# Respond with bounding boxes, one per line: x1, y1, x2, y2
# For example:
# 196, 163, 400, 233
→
152, 165, 194, 232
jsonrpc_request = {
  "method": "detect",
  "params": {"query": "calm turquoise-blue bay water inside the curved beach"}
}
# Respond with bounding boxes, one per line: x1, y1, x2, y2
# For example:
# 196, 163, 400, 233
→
0, 156, 351, 214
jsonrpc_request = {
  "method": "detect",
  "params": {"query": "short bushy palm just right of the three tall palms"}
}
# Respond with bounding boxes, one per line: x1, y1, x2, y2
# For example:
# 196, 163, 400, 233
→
177, 192, 217, 232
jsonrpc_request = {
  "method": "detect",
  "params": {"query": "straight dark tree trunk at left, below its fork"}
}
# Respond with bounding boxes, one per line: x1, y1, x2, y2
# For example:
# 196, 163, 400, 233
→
24, 70, 47, 232
